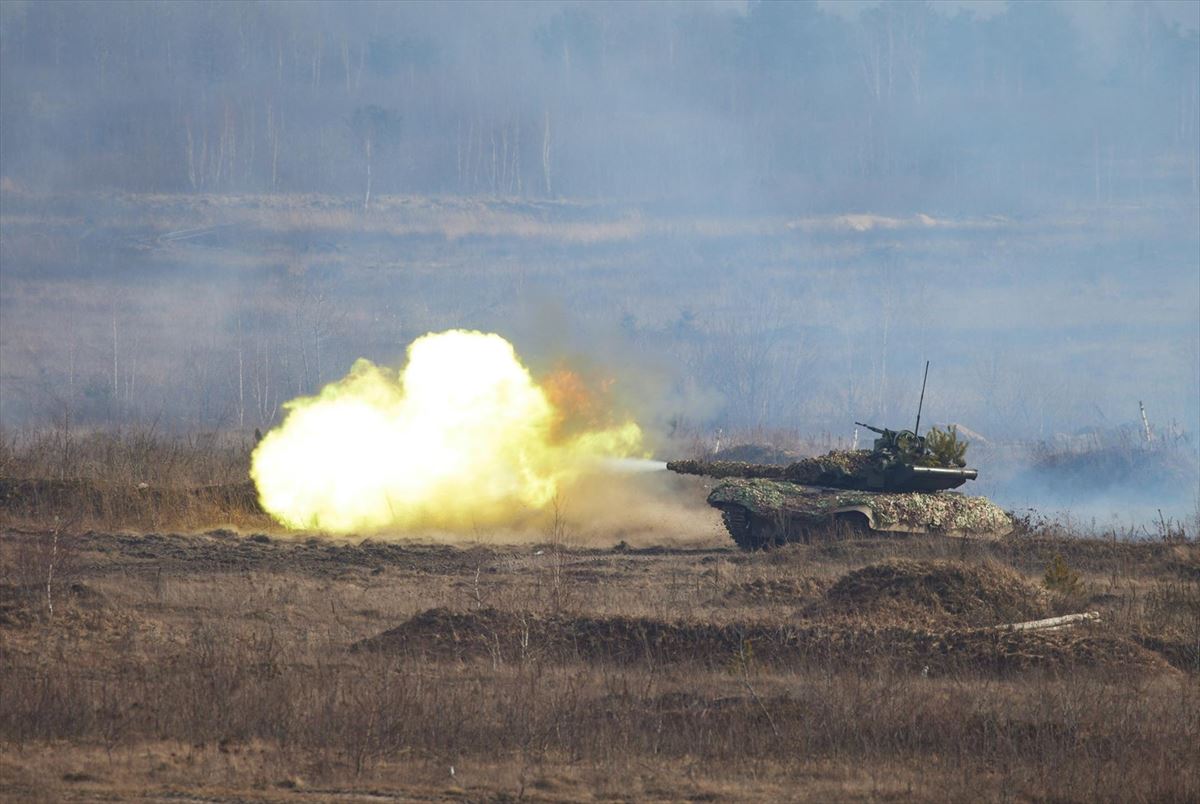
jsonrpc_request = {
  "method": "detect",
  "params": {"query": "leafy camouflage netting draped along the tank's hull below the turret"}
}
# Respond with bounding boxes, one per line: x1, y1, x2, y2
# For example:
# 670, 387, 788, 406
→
708, 479, 1013, 534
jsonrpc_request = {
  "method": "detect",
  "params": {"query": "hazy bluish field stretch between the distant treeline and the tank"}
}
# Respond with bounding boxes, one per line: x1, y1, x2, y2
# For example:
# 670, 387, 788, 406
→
0, 188, 1200, 442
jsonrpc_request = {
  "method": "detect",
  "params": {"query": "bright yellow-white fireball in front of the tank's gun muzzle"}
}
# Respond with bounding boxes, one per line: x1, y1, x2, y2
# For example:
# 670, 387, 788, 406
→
251, 330, 642, 534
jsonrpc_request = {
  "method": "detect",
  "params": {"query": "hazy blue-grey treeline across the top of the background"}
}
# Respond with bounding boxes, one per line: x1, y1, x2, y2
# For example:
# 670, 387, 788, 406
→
0, 0, 1200, 209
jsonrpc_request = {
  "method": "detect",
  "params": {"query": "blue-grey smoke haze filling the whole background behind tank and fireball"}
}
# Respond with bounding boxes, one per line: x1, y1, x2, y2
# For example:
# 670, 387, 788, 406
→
0, 1, 1200, 528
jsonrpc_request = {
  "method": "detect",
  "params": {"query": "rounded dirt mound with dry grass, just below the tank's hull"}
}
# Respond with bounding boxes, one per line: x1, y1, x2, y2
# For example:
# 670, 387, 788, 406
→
826, 559, 1049, 626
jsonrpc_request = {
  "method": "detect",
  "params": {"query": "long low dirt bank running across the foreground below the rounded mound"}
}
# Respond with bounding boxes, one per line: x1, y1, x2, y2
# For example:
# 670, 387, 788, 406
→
353, 608, 1169, 674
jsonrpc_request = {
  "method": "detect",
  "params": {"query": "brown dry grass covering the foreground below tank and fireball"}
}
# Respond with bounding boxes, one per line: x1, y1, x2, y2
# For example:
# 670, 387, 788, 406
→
0, 433, 1200, 802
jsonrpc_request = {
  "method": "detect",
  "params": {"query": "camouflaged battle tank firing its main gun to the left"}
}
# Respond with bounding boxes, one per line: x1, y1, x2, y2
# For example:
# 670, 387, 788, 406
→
667, 422, 1013, 550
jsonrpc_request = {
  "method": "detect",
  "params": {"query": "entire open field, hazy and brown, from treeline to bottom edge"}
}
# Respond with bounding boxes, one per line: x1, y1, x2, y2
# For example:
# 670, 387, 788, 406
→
0, 192, 1200, 800
